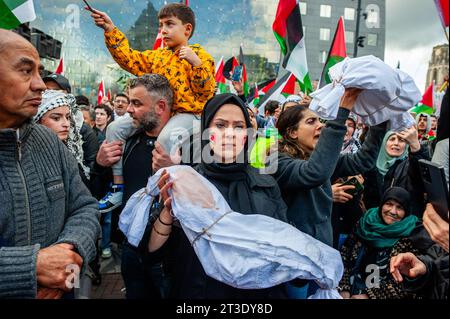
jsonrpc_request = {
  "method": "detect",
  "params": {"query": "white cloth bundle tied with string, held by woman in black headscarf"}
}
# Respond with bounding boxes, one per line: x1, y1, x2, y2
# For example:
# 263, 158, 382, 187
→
119, 166, 344, 299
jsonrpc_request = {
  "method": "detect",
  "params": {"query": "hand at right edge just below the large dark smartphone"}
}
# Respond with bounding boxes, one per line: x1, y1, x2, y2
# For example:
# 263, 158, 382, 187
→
423, 203, 449, 253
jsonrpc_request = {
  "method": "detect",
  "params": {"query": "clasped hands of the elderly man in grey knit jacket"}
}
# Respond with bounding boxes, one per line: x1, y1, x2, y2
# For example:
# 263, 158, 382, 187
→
36, 244, 83, 291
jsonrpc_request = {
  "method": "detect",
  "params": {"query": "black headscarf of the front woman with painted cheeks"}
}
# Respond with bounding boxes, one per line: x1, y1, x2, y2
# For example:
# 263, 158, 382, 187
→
200, 93, 256, 214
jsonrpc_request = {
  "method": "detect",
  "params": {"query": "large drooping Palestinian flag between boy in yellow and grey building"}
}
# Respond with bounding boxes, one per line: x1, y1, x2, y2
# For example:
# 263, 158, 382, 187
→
272, 0, 313, 94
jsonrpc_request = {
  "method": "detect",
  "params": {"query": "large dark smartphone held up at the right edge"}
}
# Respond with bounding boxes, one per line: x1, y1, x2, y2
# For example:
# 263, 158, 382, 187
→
419, 160, 449, 222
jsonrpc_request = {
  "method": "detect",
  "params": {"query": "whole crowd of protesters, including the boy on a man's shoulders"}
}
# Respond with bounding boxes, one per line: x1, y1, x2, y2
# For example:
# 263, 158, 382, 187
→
0, 4, 449, 299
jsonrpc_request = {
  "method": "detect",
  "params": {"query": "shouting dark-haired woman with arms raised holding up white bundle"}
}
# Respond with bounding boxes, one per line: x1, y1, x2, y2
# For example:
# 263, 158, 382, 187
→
275, 89, 386, 297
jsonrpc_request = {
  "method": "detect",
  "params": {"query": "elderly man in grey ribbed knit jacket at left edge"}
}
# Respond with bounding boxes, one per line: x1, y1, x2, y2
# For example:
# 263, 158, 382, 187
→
0, 29, 100, 298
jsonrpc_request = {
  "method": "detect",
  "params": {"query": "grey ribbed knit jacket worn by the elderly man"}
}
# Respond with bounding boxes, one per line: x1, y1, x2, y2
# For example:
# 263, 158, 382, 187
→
0, 123, 100, 298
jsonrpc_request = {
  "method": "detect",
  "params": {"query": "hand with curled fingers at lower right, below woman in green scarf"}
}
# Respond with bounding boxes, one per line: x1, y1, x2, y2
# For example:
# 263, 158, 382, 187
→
390, 253, 427, 282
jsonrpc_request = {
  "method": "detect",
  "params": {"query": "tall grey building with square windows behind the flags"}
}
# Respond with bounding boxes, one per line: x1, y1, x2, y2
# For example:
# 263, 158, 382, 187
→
300, 0, 386, 80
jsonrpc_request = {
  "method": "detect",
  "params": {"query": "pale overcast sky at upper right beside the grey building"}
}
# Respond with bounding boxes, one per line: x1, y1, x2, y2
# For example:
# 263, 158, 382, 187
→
385, 0, 448, 93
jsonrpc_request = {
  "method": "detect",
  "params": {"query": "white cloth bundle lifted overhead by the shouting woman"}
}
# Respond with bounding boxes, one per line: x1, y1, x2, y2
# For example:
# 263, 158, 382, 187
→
309, 55, 422, 131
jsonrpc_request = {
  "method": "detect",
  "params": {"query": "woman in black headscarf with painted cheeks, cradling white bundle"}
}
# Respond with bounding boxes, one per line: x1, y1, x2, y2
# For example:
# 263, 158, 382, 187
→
151, 94, 287, 299
